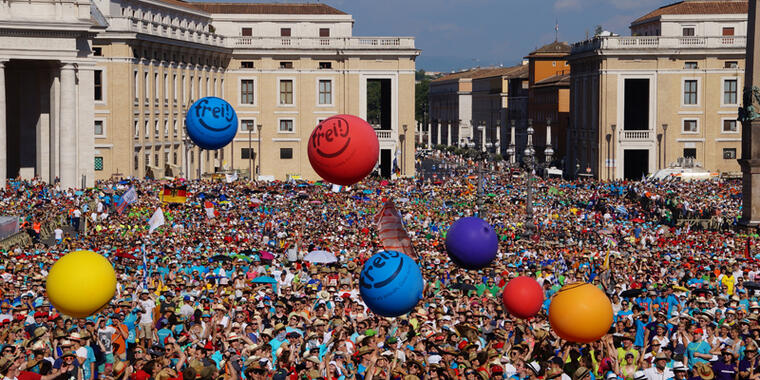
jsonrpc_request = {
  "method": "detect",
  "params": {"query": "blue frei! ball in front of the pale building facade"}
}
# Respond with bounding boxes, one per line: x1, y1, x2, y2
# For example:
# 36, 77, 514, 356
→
185, 96, 238, 150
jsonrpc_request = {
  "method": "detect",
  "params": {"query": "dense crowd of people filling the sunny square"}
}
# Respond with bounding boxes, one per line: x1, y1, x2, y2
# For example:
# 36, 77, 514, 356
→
0, 154, 760, 380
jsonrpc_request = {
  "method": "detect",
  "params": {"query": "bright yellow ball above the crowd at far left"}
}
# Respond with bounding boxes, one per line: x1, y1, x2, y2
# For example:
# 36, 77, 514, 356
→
46, 251, 116, 318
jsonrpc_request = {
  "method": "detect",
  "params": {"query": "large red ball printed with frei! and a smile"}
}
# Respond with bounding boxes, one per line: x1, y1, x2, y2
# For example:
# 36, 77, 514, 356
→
308, 115, 380, 186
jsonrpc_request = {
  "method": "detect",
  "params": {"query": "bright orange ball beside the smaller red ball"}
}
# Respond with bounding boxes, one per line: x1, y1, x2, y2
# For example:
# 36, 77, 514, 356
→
549, 283, 612, 343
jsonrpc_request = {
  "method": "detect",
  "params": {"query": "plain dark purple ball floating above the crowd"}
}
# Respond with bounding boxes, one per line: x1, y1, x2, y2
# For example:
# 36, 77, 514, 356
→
446, 217, 499, 269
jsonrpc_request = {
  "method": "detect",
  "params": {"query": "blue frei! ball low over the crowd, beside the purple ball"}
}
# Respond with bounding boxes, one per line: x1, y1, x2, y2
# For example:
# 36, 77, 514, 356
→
359, 251, 423, 317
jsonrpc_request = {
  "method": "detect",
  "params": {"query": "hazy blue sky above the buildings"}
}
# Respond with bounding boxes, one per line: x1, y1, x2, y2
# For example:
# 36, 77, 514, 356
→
316, 0, 675, 71
